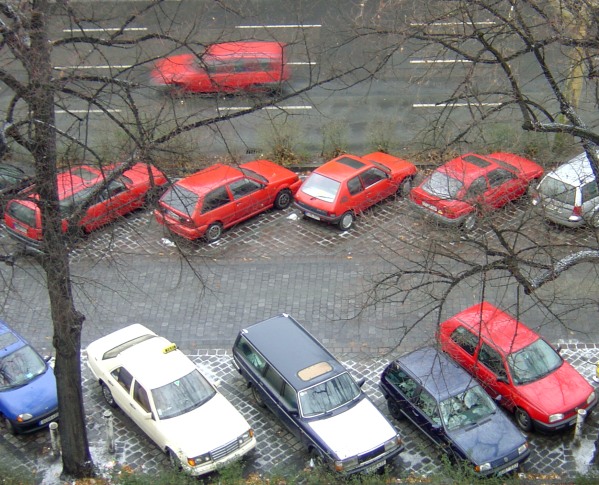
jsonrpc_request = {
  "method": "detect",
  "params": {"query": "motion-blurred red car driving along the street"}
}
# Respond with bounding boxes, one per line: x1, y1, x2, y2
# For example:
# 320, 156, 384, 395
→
150, 42, 290, 93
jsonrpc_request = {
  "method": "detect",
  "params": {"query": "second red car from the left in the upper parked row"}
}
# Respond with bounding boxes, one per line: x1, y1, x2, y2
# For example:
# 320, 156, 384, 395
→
154, 160, 301, 242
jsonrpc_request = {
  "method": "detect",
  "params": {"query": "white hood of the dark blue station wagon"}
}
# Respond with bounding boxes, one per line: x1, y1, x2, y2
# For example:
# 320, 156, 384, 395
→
308, 399, 397, 460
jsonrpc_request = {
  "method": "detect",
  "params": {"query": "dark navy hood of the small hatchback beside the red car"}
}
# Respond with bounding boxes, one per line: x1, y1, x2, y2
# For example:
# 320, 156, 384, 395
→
447, 410, 526, 465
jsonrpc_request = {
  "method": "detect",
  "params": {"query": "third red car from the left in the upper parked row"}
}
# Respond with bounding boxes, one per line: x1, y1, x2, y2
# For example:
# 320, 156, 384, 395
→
294, 152, 416, 231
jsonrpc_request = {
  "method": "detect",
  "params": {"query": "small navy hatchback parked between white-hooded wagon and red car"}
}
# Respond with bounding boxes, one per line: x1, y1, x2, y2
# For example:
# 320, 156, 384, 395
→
380, 347, 530, 476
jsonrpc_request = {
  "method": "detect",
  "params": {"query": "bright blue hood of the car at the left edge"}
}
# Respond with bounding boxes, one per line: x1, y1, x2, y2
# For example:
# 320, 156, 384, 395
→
0, 367, 58, 419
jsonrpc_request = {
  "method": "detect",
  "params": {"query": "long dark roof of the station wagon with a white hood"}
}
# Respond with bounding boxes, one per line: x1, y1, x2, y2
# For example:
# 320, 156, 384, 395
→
240, 313, 346, 390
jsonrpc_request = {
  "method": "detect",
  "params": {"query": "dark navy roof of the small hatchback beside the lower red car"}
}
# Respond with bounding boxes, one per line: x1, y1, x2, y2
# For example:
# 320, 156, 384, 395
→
396, 347, 477, 401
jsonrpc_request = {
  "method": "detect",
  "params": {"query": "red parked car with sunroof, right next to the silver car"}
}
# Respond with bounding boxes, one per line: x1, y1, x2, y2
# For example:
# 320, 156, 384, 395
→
410, 152, 543, 231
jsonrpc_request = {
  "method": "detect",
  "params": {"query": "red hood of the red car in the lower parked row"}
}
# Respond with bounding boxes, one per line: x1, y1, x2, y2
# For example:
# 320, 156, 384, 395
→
517, 361, 593, 415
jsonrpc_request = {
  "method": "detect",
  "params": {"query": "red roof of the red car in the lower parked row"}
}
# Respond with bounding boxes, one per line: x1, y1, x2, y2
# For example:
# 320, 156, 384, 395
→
446, 301, 540, 355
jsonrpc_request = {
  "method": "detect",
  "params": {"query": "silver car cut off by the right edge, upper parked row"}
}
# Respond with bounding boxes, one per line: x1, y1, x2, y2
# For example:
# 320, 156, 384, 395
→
532, 153, 599, 227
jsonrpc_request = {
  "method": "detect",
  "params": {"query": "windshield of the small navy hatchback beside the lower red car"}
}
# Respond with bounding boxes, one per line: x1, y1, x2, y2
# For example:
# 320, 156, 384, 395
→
440, 386, 496, 430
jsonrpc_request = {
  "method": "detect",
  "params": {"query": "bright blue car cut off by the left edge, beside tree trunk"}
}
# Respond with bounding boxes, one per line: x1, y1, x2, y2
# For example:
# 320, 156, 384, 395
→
0, 320, 58, 434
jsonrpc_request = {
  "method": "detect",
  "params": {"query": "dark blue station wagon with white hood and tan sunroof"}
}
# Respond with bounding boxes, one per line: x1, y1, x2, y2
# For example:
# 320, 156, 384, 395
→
233, 314, 403, 474
